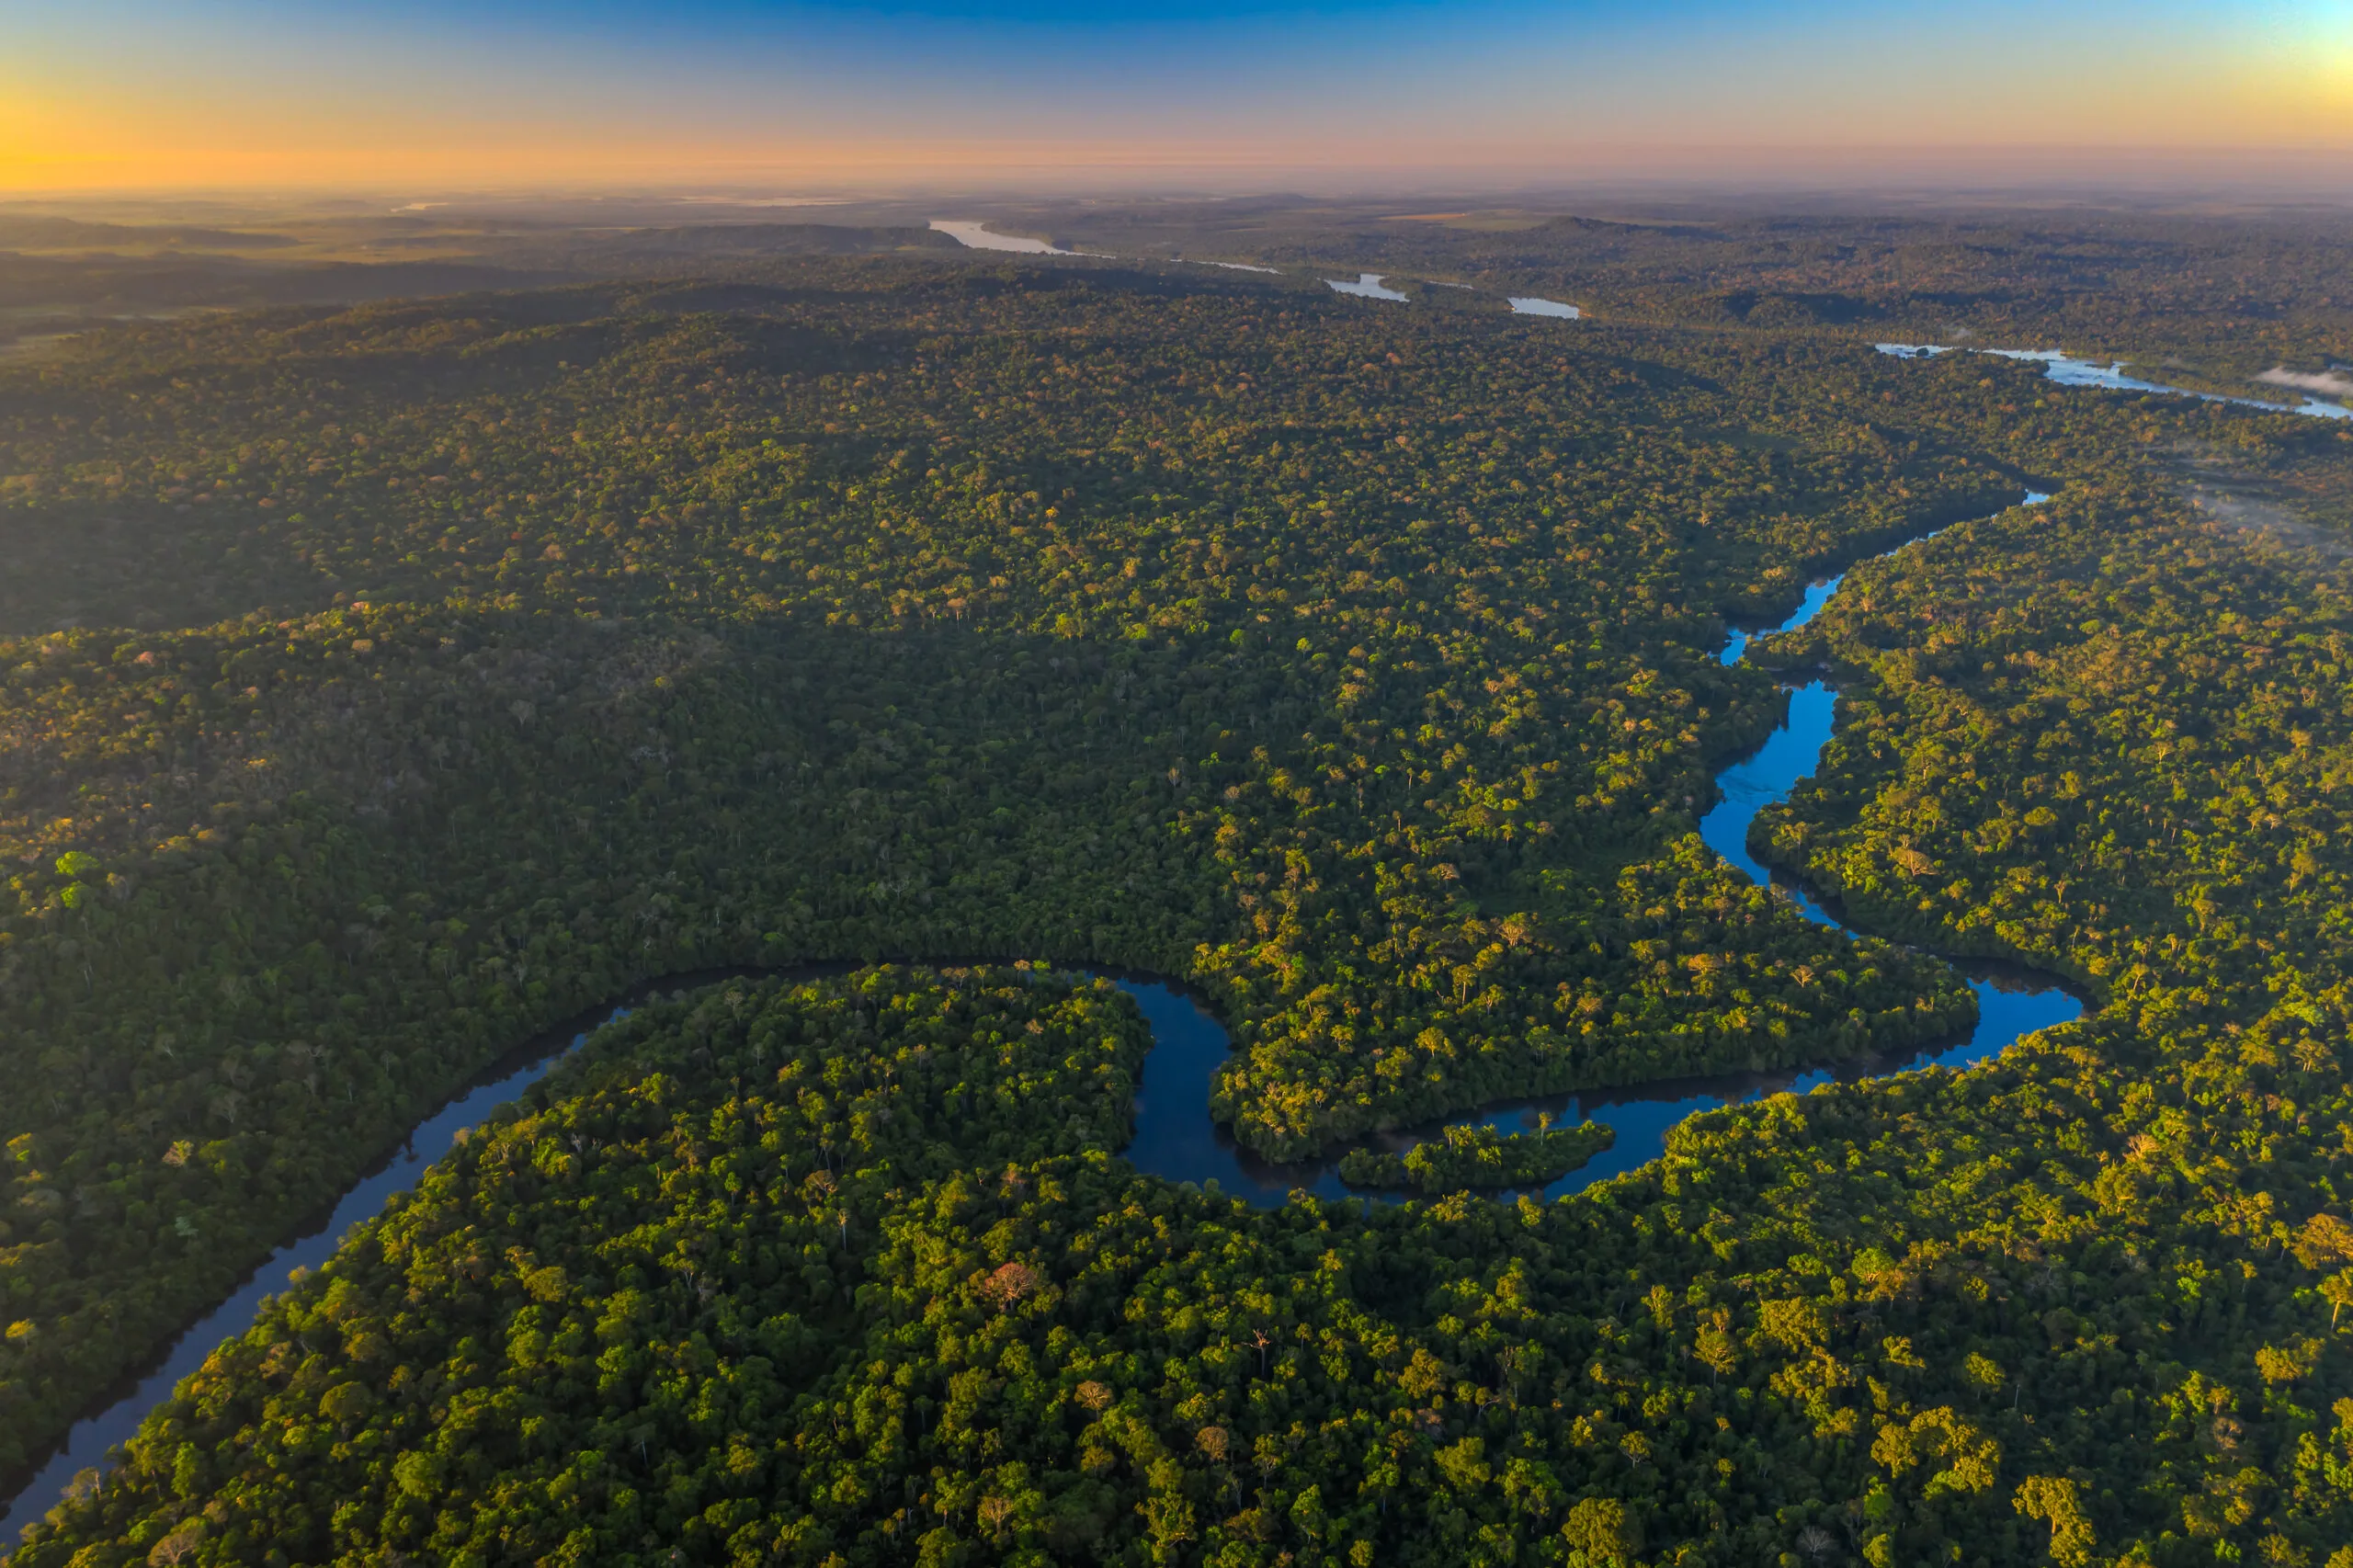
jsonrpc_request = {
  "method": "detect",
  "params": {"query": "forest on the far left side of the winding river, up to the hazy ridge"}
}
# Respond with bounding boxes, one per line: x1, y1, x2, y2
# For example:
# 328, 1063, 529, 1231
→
0, 268, 2017, 1487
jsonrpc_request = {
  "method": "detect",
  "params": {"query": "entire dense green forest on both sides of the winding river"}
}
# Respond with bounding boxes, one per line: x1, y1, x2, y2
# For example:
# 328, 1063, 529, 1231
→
0, 235, 2353, 1568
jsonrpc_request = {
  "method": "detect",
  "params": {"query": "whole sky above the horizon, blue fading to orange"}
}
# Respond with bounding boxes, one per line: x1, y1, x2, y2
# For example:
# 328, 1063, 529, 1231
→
0, 0, 2353, 196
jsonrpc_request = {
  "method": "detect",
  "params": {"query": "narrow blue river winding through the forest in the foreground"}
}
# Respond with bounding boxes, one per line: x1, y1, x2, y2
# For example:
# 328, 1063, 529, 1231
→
0, 501, 2083, 1526
